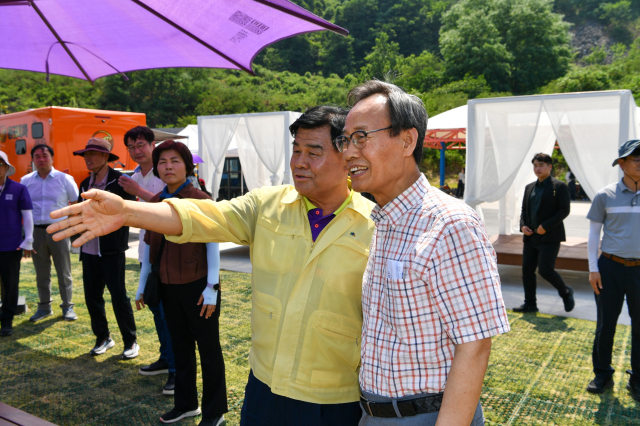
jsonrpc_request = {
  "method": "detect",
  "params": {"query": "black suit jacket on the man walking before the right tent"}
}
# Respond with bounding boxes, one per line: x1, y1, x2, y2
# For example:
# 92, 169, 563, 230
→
520, 177, 571, 243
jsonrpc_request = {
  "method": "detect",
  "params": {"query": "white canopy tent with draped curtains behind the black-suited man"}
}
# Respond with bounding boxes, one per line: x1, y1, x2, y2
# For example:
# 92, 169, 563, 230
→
465, 90, 640, 235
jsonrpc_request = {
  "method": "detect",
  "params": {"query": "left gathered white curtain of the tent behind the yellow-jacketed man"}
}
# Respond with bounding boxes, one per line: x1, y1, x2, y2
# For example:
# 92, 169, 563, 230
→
198, 117, 240, 200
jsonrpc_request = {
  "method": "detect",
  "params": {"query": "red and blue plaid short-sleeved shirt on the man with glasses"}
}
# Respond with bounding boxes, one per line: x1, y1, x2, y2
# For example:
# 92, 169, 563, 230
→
360, 176, 510, 398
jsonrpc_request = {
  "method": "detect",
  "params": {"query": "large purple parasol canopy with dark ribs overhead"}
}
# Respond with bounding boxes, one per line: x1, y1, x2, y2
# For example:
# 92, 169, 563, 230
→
0, 0, 348, 81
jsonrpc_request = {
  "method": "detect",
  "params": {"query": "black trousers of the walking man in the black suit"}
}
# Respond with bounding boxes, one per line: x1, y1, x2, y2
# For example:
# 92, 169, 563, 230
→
522, 241, 567, 305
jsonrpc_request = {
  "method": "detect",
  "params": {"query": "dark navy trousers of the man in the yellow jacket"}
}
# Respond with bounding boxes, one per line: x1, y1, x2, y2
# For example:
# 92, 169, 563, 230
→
240, 371, 362, 426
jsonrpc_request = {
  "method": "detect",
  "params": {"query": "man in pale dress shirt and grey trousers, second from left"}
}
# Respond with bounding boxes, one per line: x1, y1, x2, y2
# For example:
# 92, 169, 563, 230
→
20, 144, 78, 322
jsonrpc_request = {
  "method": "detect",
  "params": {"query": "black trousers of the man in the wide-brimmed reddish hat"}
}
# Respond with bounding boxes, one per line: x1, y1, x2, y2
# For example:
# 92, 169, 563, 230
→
82, 253, 136, 348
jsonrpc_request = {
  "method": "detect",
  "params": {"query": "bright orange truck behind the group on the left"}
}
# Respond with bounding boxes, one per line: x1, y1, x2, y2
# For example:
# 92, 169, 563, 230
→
0, 107, 147, 185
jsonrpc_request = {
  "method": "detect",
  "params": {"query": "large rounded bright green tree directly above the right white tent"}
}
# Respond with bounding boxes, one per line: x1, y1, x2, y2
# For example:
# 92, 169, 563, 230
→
440, 0, 571, 93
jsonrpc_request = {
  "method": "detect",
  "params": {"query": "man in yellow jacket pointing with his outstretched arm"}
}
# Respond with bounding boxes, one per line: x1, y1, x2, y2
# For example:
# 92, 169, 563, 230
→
49, 106, 374, 426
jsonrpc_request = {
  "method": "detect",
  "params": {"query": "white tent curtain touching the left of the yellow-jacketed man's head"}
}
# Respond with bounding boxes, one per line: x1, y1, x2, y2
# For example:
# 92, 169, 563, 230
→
244, 115, 285, 186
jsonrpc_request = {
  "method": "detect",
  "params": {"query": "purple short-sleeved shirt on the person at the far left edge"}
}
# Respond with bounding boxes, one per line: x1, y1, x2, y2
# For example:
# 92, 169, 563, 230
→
0, 177, 33, 251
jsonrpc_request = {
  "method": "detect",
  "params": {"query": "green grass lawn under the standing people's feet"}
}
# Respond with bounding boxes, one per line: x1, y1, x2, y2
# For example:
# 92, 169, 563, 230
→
0, 256, 640, 426
